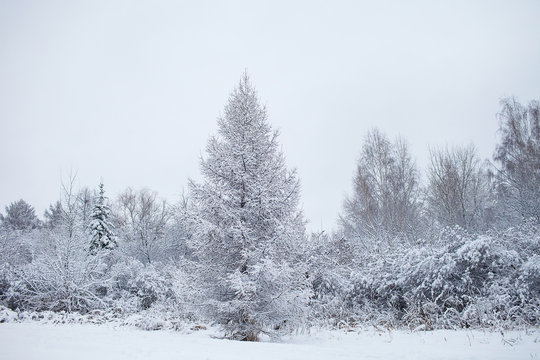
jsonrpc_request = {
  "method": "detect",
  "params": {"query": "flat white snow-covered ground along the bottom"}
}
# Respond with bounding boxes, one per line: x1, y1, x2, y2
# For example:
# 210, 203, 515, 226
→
0, 323, 540, 360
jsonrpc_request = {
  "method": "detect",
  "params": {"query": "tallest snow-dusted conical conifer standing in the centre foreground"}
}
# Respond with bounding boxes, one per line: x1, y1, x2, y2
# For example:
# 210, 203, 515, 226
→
186, 74, 309, 340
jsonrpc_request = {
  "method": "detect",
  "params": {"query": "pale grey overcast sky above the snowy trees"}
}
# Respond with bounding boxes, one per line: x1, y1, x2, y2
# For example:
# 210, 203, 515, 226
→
0, 0, 540, 230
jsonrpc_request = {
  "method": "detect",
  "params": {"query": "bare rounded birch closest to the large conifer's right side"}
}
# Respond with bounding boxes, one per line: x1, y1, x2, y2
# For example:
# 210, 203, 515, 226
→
339, 129, 420, 251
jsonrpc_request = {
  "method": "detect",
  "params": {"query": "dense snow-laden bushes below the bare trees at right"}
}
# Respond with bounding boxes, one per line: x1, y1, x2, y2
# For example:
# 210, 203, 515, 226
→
315, 223, 540, 329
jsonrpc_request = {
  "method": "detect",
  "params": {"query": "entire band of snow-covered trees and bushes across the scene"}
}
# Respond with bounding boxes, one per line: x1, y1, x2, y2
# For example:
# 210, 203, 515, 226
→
0, 75, 540, 340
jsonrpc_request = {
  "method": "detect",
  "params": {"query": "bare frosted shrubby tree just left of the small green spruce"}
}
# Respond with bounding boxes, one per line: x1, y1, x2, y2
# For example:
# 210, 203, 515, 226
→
7, 175, 108, 311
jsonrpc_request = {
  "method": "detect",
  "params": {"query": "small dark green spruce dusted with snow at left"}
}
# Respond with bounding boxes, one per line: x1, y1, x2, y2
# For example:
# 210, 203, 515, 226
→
89, 183, 116, 254
